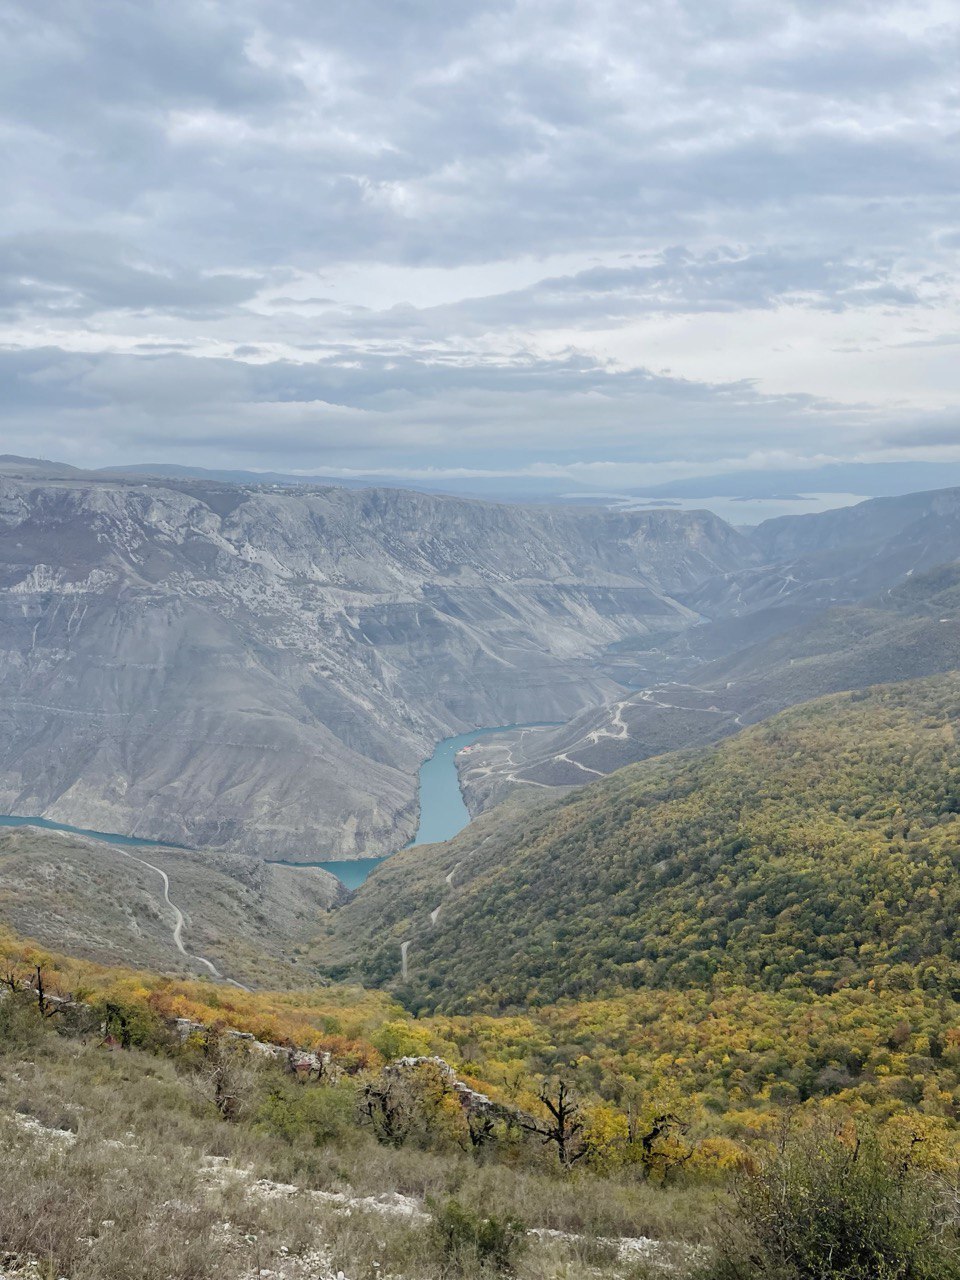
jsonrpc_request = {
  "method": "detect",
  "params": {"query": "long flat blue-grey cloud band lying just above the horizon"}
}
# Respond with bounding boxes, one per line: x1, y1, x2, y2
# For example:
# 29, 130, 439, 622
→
0, 348, 911, 468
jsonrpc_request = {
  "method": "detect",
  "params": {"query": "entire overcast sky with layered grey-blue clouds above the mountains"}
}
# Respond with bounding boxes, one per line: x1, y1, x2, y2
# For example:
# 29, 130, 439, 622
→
0, 0, 960, 486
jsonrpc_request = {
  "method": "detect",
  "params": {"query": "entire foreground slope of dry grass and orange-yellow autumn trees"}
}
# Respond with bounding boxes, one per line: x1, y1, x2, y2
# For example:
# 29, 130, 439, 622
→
0, 936, 960, 1280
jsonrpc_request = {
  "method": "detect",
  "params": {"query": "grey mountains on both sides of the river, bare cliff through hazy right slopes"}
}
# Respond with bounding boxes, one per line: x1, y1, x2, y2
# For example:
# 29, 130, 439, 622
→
0, 458, 960, 885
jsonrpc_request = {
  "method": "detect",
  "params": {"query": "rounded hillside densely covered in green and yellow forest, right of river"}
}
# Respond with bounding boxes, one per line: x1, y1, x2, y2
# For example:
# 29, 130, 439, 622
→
327, 673, 960, 1011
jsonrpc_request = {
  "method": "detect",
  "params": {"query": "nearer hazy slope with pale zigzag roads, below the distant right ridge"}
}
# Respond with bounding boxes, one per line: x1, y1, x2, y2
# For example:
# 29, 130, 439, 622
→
463, 563, 960, 809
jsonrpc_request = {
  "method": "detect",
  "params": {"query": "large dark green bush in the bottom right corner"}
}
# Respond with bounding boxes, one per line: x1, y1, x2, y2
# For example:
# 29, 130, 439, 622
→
700, 1132, 960, 1280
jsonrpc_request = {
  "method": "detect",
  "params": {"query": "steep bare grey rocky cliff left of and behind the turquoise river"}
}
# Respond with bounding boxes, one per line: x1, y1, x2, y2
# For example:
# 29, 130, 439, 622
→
0, 477, 755, 860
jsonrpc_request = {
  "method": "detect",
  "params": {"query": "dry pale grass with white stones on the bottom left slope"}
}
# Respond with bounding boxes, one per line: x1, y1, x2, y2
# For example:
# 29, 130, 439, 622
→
0, 1025, 709, 1280
